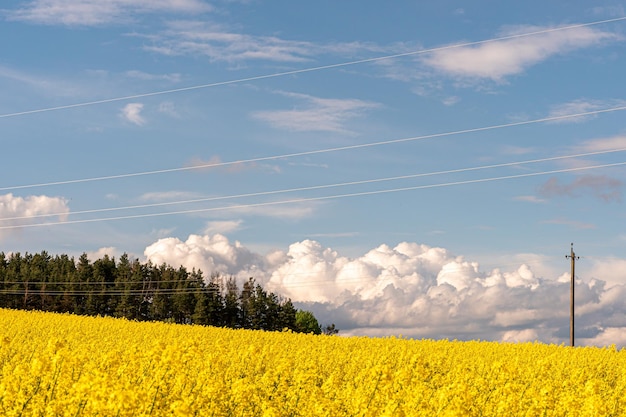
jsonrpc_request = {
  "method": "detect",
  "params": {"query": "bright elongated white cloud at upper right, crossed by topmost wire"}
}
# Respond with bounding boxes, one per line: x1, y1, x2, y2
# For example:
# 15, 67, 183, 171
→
422, 26, 618, 82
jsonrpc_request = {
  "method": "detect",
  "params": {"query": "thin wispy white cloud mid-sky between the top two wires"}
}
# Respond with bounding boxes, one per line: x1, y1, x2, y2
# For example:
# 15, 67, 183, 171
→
252, 92, 378, 134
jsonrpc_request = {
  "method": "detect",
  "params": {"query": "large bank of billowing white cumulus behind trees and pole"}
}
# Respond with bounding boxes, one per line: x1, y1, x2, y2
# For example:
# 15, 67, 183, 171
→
145, 235, 626, 346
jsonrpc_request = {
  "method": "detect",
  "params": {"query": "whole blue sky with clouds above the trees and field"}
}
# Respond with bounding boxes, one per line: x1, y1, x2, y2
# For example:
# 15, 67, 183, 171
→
0, 0, 626, 345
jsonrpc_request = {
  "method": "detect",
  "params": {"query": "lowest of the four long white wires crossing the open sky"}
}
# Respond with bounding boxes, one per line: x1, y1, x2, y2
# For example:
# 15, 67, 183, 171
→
0, 162, 626, 230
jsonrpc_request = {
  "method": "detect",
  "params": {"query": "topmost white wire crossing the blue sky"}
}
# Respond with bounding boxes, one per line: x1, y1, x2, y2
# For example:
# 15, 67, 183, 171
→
0, 16, 626, 118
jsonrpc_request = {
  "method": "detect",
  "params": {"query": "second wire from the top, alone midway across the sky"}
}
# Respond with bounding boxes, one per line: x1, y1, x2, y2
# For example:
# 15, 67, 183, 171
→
0, 106, 626, 191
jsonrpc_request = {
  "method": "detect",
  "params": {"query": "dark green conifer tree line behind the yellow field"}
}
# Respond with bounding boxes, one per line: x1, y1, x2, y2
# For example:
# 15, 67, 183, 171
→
0, 251, 338, 334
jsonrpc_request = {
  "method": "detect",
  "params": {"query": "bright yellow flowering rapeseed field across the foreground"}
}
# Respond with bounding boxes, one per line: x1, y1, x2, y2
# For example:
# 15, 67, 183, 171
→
0, 309, 626, 417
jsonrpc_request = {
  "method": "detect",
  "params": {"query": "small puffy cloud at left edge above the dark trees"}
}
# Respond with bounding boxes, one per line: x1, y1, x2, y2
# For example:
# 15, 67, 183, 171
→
0, 193, 70, 238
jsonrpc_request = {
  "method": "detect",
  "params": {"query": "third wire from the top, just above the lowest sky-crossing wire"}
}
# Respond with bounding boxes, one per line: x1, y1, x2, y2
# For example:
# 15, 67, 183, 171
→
0, 148, 626, 221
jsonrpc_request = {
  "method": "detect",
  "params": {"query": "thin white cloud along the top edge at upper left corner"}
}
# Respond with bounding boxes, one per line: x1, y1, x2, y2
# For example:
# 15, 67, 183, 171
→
8, 0, 211, 26
